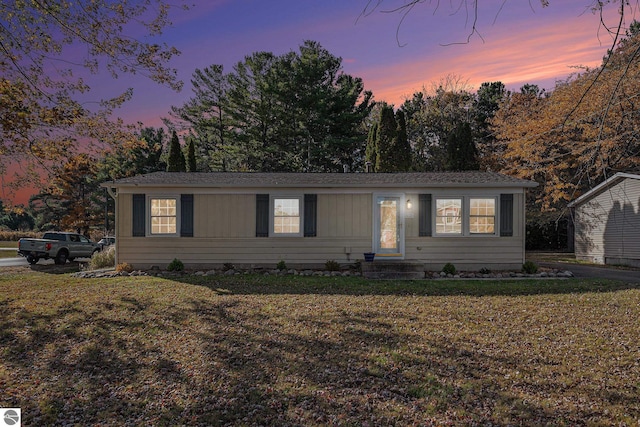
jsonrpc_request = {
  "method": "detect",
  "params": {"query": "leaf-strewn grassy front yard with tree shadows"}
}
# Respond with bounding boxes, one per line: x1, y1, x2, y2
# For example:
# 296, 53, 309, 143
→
0, 272, 640, 426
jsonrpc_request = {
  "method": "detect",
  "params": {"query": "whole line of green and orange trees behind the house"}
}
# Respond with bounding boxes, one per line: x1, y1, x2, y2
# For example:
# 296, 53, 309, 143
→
3, 23, 640, 251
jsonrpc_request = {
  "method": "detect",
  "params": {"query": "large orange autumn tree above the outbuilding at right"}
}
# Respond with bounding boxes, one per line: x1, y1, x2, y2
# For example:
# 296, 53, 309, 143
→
493, 26, 640, 211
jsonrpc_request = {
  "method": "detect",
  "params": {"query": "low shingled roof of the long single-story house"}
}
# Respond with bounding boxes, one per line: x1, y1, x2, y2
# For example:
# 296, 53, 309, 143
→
102, 171, 538, 188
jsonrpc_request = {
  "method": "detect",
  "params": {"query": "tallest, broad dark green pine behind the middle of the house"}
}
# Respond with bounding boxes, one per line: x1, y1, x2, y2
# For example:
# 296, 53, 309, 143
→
172, 41, 373, 172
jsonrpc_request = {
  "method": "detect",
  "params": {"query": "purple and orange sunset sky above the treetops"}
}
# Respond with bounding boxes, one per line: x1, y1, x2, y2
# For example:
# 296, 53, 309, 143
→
0, 0, 635, 203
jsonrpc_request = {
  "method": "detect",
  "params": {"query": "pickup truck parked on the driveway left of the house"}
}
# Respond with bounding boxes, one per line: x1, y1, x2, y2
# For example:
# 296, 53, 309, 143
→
18, 231, 100, 264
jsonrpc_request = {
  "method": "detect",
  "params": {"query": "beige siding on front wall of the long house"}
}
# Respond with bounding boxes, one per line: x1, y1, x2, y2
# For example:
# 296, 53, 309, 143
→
117, 189, 524, 270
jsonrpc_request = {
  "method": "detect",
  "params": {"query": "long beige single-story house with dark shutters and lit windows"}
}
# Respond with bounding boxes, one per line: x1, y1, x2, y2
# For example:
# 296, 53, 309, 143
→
103, 172, 537, 270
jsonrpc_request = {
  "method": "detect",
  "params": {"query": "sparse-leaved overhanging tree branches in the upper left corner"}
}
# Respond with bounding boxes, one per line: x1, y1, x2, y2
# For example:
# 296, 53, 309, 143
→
0, 0, 181, 189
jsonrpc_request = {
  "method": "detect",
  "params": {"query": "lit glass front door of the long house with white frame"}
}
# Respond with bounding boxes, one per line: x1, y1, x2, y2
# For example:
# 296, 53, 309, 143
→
374, 196, 404, 258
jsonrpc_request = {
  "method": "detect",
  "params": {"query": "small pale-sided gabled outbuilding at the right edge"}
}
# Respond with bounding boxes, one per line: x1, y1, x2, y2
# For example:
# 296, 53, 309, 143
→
568, 173, 640, 267
